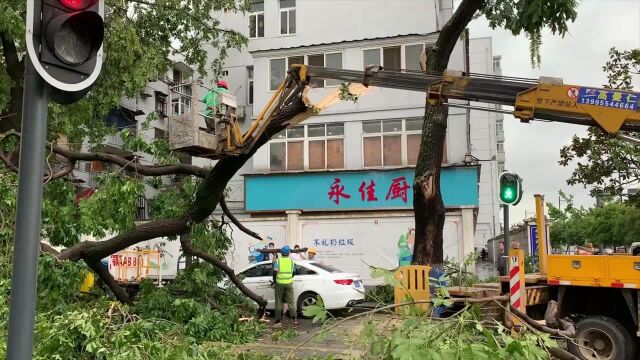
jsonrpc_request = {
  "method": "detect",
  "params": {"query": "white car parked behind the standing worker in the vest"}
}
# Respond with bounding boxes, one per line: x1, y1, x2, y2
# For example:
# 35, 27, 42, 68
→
225, 260, 364, 311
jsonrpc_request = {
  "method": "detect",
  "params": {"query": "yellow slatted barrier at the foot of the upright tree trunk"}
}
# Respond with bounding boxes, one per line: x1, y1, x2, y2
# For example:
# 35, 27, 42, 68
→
393, 265, 431, 314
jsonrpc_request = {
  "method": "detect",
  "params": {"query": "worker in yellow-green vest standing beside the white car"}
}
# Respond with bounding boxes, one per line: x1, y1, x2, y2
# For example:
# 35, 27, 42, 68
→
273, 245, 298, 326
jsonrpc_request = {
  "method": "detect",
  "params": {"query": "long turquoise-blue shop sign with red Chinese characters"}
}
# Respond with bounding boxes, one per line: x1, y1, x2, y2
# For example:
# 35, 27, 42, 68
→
245, 166, 480, 211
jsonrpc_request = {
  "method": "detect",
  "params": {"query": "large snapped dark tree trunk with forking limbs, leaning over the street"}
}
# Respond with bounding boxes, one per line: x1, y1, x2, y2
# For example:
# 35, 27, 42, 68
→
40, 74, 308, 306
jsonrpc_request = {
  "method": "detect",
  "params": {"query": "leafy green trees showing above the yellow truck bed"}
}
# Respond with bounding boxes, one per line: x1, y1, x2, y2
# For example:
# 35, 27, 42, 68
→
547, 192, 640, 247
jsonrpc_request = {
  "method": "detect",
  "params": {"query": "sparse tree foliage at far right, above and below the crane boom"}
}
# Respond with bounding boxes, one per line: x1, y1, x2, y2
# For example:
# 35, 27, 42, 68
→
560, 48, 640, 204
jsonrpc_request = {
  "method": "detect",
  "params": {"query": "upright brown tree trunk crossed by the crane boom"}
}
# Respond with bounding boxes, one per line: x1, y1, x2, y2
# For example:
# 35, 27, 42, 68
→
412, 0, 483, 267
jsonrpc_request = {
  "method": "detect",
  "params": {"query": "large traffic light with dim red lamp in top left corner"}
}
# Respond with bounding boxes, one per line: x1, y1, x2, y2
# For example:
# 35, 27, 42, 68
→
26, 0, 105, 103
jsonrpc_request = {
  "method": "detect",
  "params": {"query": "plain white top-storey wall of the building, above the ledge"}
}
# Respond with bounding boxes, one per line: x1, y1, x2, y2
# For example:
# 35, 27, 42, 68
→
215, 0, 444, 51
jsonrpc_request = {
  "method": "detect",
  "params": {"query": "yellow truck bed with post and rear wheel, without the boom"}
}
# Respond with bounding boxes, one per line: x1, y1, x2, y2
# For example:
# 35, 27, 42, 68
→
510, 195, 640, 360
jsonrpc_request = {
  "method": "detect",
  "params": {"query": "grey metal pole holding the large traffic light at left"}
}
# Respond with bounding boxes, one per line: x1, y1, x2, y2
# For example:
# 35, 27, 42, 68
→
7, 56, 48, 360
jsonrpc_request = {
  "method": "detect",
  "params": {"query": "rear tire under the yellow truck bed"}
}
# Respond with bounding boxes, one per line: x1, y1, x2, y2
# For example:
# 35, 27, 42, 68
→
568, 316, 635, 360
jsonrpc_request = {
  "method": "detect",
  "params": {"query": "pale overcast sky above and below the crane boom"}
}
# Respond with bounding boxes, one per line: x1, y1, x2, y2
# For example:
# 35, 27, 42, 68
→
469, 0, 640, 223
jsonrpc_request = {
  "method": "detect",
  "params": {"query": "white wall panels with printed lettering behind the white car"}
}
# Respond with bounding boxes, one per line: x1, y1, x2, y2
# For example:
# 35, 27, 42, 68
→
227, 212, 464, 285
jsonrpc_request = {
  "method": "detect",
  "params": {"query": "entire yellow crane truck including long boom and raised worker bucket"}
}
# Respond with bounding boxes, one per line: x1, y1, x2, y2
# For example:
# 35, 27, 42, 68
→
169, 65, 640, 360
